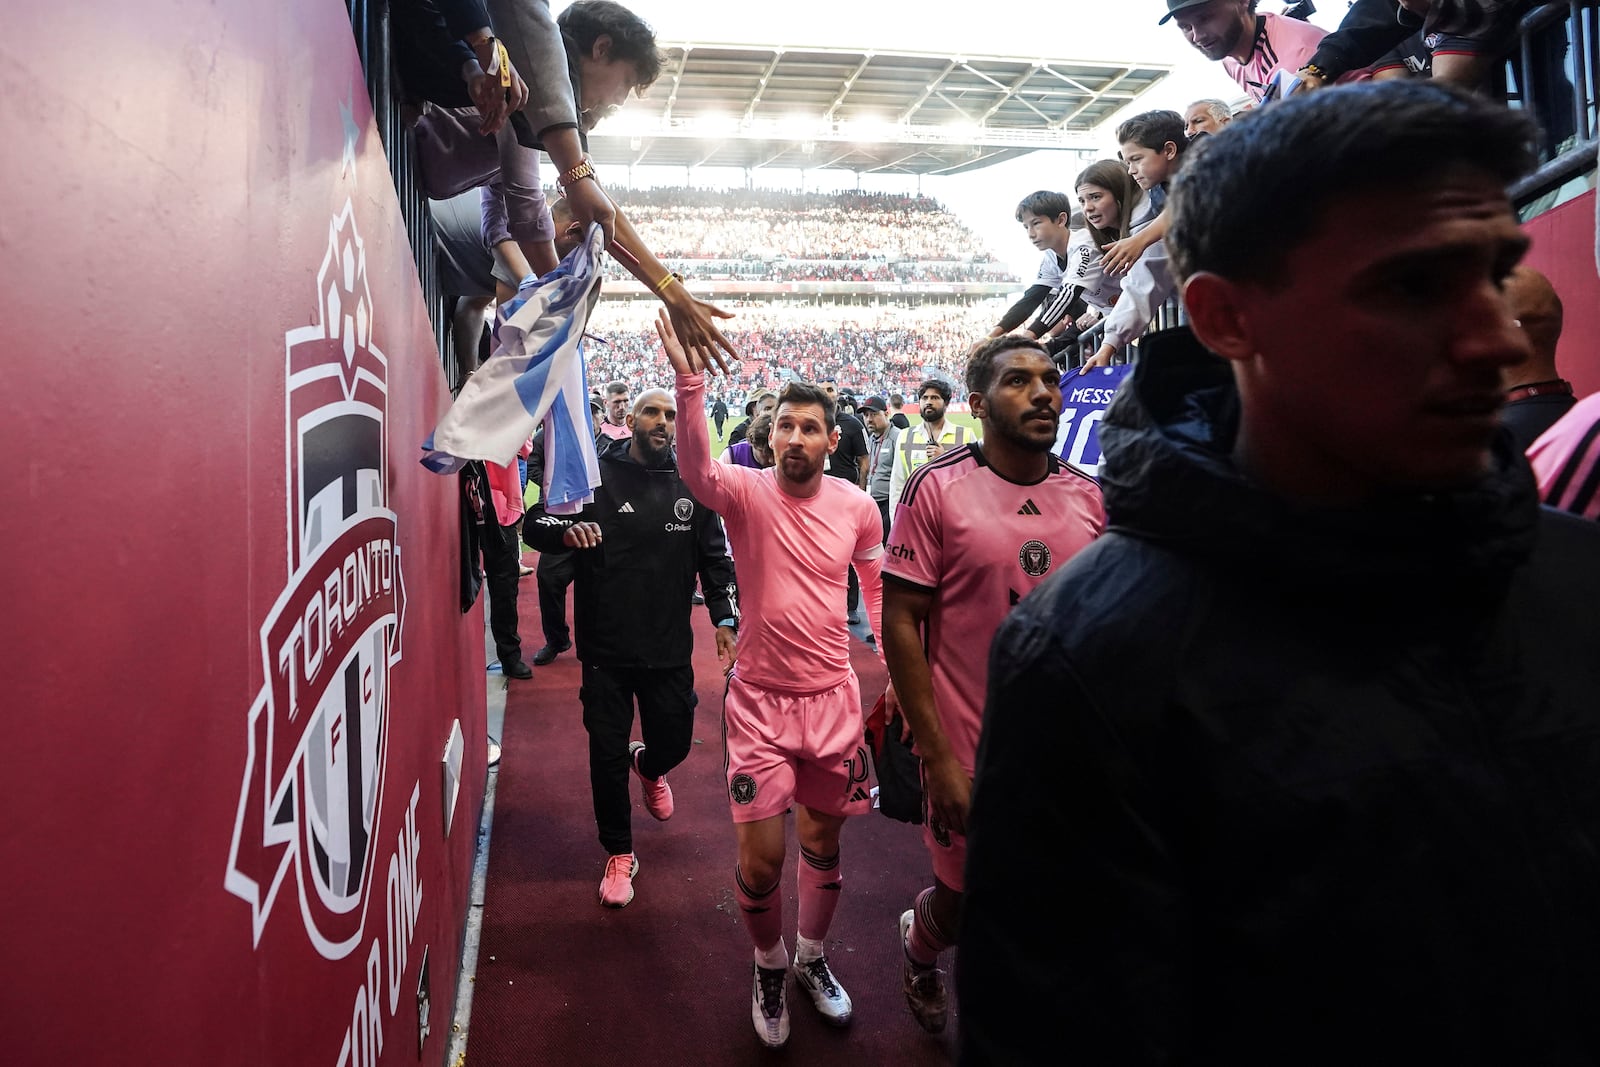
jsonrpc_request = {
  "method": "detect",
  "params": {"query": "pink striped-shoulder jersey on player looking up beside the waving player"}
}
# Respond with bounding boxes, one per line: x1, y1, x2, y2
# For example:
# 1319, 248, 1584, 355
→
883, 445, 1106, 774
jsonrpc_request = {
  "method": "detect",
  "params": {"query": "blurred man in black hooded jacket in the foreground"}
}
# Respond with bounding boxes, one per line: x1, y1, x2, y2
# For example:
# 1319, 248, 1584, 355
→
957, 83, 1600, 1067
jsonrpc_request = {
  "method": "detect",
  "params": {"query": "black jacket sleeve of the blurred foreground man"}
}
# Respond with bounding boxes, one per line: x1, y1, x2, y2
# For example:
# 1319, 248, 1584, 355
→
957, 609, 1187, 1065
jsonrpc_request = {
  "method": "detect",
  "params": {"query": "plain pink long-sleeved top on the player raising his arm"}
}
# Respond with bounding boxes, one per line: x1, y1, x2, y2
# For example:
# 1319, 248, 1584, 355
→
677, 374, 883, 693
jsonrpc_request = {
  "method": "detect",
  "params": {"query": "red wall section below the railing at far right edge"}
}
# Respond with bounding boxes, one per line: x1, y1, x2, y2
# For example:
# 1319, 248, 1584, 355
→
1523, 192, 1600, 397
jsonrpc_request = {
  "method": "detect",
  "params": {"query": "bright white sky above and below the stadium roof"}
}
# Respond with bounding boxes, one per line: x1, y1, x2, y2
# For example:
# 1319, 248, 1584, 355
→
552, 0, 1346, 282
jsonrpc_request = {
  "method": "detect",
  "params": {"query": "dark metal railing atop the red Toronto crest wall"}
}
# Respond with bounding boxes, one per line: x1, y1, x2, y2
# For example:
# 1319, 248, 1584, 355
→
346, 0, 459, 382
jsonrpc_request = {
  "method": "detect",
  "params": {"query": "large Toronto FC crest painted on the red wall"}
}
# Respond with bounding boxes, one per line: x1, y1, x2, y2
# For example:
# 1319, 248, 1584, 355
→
224, 200, 405, 960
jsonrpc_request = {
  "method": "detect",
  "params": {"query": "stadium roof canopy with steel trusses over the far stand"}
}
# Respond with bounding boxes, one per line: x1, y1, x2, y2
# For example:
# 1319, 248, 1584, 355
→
590, 43, 1170, 174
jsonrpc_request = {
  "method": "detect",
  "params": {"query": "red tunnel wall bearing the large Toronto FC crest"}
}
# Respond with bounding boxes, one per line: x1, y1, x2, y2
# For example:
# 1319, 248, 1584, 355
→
0, 0, 485, 1067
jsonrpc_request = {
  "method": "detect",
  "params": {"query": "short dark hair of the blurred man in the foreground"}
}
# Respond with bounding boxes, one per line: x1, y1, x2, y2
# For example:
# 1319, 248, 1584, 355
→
1166, 82, 1538, 285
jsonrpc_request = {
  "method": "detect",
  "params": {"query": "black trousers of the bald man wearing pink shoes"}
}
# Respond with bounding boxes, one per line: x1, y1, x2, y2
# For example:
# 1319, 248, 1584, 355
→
578, 664, 698, 856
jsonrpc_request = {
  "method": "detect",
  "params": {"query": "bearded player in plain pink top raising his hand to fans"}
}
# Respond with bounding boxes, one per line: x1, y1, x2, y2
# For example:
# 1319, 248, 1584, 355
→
656, 315, 896, 1048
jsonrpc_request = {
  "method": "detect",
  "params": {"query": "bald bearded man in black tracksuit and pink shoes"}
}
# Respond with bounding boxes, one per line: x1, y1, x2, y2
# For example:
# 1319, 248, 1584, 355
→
526, 389, 739, 907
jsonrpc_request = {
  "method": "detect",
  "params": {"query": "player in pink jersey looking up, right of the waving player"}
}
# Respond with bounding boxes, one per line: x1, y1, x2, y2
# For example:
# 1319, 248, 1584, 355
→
883, 336, 1106, 1033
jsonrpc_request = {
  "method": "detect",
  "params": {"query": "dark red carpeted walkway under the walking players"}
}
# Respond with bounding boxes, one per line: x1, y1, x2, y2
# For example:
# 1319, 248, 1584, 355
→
467, 577, 957, 1067
